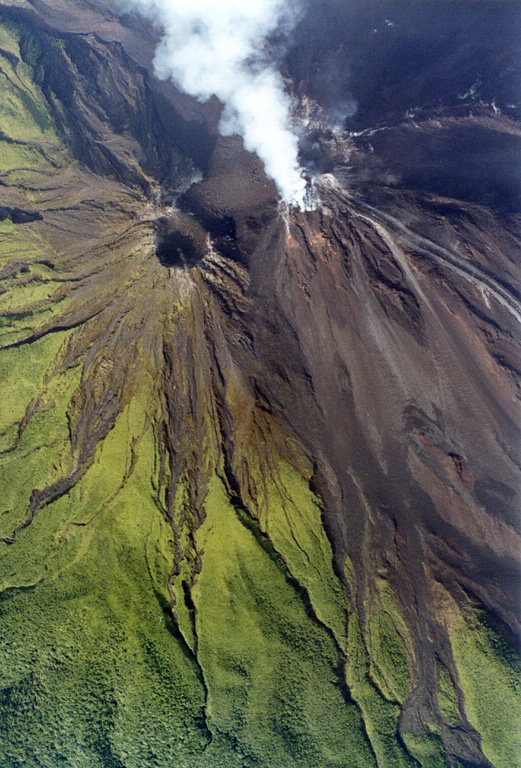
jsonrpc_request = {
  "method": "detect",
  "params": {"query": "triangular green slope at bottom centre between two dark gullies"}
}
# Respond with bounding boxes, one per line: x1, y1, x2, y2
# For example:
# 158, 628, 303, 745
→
193, 478, 375, 768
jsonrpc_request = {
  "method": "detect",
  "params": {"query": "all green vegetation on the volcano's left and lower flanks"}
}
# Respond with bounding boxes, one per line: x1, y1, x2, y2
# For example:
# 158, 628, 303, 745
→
0, 12, 515, 768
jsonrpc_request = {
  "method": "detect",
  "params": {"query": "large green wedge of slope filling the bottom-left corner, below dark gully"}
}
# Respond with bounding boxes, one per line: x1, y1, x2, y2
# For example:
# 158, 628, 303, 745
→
0, 400, 209, 768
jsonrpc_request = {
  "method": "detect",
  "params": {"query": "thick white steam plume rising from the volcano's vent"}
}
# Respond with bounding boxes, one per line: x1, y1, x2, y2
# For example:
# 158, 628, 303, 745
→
125, 0, 306, 208
